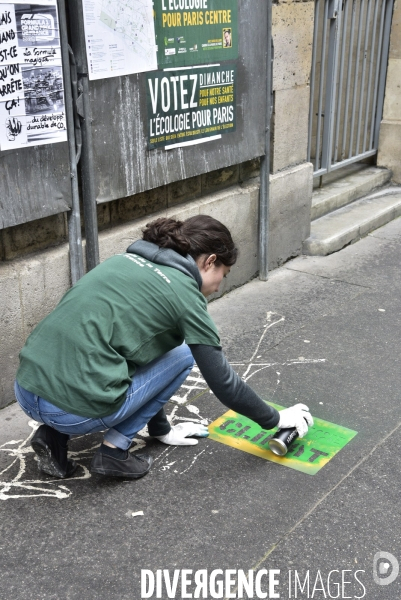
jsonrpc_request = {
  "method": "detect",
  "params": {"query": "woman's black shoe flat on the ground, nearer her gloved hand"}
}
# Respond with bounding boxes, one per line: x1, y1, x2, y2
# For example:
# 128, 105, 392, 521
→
90, 448, 153, 479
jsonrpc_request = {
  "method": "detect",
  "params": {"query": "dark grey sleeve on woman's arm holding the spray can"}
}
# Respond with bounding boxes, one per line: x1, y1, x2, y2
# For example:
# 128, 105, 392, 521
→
189, 344, 280, 429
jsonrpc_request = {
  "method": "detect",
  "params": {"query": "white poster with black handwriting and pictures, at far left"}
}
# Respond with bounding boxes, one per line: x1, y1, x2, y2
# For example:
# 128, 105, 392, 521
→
0, 0, 67, 150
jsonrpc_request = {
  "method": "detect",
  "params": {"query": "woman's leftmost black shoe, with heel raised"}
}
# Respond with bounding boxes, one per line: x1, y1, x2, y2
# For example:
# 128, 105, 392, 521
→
31, 425, 77, 479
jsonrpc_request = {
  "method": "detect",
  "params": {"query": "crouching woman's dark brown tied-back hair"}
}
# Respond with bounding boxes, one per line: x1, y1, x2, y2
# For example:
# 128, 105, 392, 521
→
142, 215, 238, 267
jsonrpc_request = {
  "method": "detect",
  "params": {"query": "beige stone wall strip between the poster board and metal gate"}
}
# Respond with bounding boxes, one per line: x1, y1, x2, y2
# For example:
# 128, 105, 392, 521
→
269, 1, 314, 269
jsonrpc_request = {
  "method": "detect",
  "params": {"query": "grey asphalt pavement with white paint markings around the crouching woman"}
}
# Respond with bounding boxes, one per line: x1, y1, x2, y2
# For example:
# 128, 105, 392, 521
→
0, 219, 401, 600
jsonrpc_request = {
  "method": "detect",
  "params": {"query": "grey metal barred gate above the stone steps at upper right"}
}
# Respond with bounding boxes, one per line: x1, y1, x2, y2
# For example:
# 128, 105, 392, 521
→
308, 0, 394, 176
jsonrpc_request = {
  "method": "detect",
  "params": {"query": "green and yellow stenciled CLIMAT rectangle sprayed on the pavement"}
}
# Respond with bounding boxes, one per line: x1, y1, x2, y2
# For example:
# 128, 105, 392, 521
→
209, 402, 358, 475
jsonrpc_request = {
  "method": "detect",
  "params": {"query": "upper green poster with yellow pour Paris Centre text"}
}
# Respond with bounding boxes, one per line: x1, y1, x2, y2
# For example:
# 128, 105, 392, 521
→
154, 0, 234, 69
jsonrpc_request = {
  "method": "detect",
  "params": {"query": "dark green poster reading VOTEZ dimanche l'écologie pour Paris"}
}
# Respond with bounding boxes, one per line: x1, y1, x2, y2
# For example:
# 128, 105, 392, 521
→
146, 63, 237, 149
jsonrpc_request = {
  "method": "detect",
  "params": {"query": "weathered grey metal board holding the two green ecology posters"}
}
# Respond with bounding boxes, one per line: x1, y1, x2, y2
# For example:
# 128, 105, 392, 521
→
81, 0, 267, 203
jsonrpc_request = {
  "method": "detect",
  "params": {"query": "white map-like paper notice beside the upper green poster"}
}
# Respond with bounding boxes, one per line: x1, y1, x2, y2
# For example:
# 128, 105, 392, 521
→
83, 0, 157, 79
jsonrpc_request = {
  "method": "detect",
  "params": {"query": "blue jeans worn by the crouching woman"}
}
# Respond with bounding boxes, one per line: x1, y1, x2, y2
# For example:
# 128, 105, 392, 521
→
14, 344, 194, 450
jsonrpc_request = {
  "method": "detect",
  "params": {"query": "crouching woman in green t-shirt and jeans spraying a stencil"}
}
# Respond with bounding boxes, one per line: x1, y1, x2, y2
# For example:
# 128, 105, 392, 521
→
15, 215, 312, 479
